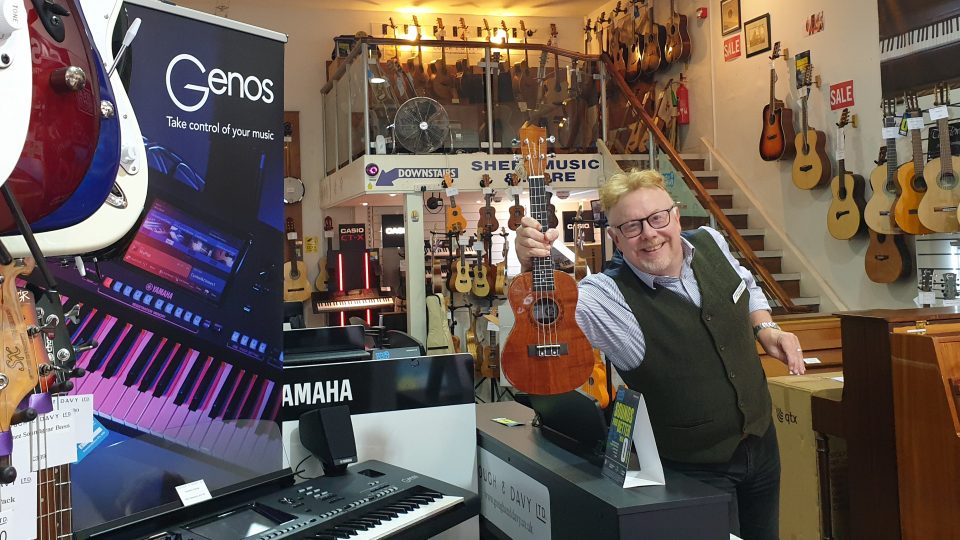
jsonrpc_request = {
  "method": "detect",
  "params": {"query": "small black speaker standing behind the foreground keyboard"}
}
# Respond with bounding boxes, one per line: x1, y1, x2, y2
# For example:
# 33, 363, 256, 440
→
300, 405, 357, 476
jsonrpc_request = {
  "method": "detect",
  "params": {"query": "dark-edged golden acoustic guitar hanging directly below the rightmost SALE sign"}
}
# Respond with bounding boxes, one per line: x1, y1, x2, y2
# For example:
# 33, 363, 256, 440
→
827, 109, 866, 240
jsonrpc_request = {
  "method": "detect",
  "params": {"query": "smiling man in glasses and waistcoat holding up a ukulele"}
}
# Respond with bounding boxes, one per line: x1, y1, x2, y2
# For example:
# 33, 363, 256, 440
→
516, 170, 805, 540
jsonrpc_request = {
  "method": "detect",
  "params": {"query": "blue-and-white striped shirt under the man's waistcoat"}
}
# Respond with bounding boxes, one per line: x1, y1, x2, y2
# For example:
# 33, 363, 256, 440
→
576, 227, 770, 371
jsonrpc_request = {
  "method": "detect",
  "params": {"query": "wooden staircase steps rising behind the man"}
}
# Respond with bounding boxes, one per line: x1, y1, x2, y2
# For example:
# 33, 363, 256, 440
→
619, 154, 820, 315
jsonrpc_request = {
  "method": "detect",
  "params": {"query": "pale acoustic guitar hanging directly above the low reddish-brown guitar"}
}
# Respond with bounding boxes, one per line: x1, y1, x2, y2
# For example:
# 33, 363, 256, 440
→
863, 98, 903, 234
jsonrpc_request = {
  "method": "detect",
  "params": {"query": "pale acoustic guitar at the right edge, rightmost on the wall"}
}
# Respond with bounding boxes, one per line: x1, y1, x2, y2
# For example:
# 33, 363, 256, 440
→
918, 84, 960, 232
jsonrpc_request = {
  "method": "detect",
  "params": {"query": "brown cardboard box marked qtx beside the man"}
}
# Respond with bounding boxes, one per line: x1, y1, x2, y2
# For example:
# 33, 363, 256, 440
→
768, 372, 847, 540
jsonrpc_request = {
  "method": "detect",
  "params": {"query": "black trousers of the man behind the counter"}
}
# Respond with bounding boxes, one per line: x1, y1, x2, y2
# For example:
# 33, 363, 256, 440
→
663, 422, 780, 540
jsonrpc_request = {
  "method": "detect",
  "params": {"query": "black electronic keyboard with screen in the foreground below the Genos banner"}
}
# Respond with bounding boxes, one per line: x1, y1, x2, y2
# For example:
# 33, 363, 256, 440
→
104, 461, 480, 540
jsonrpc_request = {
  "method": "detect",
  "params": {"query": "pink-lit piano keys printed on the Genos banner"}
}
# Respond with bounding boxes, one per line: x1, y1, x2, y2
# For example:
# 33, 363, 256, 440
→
57, 290, 280, 461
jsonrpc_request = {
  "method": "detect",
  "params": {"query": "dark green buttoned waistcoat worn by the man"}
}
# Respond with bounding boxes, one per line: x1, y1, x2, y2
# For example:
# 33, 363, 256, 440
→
605, 230, 771, 463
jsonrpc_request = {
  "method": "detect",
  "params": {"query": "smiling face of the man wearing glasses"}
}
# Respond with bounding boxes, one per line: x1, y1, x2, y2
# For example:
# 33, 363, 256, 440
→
608, 187, 683, 277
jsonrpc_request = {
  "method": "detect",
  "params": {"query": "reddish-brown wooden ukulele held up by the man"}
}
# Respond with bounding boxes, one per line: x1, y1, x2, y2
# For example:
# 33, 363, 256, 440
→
501, 123, 593, 394
